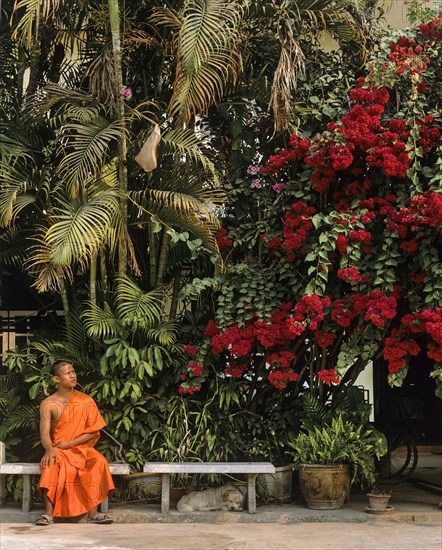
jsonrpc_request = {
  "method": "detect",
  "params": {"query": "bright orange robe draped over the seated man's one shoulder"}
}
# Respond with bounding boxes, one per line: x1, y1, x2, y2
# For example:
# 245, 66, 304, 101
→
39, 390, 115, 517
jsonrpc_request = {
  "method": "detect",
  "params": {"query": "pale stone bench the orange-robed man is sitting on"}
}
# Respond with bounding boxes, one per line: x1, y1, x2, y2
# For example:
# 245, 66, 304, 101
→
0, 441, 130, 512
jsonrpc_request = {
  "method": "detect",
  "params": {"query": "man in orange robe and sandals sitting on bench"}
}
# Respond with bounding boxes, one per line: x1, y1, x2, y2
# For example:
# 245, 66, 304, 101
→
36, 361, 115, 525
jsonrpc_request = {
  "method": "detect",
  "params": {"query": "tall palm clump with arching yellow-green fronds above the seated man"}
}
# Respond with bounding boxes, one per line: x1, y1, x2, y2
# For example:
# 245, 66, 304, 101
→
0, 0, 384, 344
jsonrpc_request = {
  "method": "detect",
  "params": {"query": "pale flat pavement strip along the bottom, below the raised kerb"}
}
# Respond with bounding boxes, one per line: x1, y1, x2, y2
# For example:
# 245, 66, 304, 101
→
0, 521, 442, 550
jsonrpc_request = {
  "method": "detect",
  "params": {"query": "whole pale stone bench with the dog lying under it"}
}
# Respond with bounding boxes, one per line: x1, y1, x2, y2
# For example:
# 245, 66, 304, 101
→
143, 462, 275, 514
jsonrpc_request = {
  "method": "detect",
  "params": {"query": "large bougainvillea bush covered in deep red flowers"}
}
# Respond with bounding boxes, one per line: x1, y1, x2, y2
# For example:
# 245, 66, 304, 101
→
180, 14, 442, 420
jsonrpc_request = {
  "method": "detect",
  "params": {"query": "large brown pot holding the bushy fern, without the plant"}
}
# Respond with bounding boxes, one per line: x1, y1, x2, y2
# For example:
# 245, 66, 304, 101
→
298, 464, 350, 510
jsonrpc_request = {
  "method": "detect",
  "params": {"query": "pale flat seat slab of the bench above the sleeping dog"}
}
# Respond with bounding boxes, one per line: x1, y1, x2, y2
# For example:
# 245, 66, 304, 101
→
143, 462, 275, 474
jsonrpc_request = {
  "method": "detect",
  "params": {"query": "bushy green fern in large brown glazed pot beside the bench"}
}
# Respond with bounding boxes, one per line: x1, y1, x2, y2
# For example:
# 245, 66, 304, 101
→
291, 412, 384, 510
